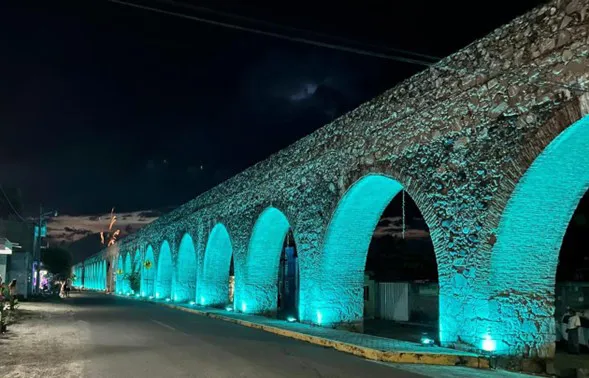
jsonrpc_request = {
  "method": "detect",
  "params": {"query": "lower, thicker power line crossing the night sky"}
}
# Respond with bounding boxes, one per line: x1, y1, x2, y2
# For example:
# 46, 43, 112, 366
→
106, 0, 434, 67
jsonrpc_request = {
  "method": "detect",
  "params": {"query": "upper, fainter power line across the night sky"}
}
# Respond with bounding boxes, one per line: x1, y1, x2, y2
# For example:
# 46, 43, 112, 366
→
156, 0, 442, 62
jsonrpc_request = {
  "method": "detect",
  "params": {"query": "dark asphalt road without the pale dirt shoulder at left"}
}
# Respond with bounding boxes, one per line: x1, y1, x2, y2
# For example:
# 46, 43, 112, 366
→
68, 294, 423, 378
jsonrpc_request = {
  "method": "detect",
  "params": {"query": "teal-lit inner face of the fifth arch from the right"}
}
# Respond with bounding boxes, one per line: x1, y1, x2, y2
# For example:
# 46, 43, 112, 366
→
173, 233, 197, 302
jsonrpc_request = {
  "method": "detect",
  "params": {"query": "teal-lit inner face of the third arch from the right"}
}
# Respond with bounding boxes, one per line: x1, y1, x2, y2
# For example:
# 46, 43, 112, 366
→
237, 207, 291, 313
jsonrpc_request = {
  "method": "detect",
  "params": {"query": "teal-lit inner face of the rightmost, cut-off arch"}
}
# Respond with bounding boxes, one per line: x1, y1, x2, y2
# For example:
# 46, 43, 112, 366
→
486, 116, 589, 357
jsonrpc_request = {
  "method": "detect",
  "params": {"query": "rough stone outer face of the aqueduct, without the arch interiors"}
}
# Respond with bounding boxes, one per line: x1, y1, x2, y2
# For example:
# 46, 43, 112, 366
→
84, 0, 589, 354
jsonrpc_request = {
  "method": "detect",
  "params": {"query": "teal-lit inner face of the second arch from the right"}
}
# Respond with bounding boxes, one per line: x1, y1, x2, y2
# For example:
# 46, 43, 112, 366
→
308, 174, 403, 325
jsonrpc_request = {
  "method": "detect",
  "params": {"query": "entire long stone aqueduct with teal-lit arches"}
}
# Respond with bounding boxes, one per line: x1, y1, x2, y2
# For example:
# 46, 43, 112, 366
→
75, 0, 589, 357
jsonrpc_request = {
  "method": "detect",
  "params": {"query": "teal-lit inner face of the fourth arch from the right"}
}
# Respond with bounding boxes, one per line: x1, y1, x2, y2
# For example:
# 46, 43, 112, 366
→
197, 223, 233, 306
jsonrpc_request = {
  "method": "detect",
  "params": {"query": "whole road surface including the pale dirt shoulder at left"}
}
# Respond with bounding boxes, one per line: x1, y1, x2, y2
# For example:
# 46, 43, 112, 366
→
0, 293, 528, 378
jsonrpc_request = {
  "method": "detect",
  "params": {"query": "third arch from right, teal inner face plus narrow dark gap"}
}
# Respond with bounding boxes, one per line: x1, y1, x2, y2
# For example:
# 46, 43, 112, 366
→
237, 207, 299, 320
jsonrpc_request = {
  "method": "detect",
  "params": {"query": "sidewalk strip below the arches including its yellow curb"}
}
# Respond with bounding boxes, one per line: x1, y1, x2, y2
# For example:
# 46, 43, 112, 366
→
122, 296, 489, 369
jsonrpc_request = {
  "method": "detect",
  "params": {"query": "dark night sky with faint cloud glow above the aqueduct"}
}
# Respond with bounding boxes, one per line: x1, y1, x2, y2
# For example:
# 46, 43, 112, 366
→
0, 0, 541, 215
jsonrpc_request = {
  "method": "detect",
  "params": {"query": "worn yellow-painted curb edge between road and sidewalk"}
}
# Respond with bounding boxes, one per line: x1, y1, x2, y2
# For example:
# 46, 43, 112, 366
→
160, 302, 490, 369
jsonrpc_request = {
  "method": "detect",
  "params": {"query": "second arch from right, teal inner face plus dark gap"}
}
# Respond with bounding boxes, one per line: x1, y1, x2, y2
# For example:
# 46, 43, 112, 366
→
306, 174, 439, 342
